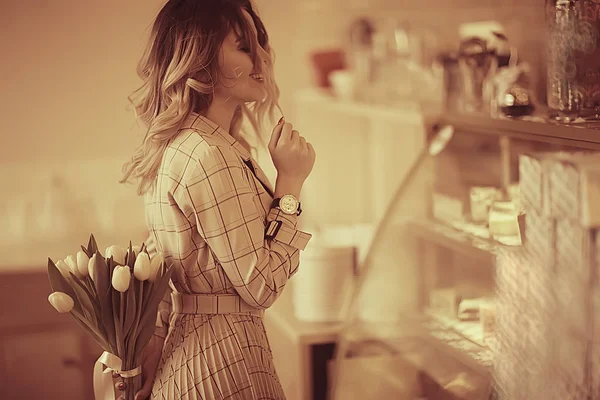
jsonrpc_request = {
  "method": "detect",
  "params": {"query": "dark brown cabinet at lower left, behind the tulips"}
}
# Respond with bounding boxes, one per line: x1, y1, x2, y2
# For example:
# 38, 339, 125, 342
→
0, 269, 99, 400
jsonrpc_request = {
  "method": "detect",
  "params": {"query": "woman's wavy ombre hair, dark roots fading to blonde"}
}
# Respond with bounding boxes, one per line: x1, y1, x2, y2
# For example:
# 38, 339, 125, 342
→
120, 0, 279, 195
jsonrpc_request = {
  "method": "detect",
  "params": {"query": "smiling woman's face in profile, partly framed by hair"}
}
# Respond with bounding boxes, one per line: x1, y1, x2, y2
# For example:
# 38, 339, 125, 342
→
215, 14, 266, 104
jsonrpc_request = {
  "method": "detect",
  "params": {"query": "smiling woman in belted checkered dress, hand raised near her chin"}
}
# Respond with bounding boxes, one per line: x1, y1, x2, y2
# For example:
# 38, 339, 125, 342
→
120, 0, 315, 400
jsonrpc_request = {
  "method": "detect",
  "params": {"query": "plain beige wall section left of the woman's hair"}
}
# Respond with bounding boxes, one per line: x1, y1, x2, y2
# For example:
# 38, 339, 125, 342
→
0, 0, 162, 256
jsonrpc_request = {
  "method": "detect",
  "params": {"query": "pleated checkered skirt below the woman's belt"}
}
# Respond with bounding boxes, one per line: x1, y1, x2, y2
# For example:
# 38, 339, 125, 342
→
151, 314, 285, 400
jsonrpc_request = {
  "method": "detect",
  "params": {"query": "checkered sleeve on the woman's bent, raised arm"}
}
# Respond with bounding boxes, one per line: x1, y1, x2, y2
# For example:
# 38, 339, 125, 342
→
174, 146, 311, 309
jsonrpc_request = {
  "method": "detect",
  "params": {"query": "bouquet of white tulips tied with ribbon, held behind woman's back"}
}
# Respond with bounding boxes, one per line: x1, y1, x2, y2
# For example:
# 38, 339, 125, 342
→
48, 235, 171, 400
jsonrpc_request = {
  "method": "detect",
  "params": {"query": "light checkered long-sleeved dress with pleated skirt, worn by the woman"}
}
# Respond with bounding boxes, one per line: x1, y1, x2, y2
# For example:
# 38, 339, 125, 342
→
145, 114, 310, 400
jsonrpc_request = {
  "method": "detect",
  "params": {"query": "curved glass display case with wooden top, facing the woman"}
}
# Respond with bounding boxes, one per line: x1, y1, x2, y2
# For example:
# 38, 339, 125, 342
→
331, 115, 600, 400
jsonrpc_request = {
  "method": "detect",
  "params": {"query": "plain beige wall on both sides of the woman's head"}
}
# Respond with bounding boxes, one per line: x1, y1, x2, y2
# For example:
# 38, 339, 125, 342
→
0, 0, 543, 268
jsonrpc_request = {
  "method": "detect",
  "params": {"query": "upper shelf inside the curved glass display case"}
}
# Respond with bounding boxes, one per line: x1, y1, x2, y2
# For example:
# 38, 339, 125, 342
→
408, 219, 496, 265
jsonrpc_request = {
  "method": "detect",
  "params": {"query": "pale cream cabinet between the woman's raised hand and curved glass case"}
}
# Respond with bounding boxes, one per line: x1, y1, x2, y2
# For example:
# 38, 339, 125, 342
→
291, 89, 425, 227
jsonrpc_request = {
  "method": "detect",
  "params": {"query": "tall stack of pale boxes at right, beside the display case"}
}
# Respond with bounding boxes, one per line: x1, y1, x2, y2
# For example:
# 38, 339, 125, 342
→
494, 153, 600, 400
